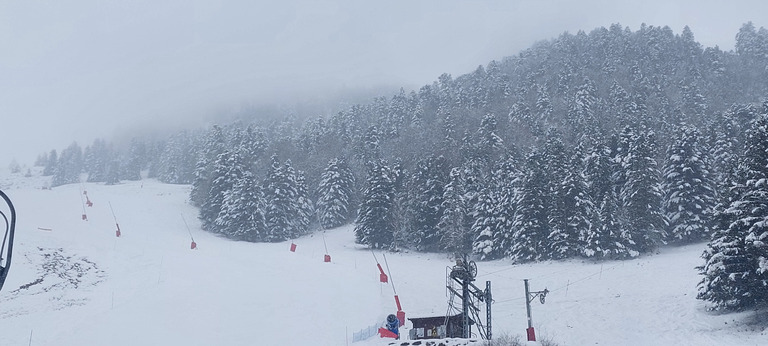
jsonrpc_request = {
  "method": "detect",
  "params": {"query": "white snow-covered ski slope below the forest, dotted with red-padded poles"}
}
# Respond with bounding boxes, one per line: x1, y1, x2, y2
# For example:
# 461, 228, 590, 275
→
0, 172, 768, 346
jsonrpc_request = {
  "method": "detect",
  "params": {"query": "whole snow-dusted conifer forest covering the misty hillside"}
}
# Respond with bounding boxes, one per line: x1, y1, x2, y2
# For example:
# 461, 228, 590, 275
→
37, 23, 768, 310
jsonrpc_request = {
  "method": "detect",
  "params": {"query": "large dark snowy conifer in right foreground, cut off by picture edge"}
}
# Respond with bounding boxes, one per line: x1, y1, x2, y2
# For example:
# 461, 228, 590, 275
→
697, 116, 768, 311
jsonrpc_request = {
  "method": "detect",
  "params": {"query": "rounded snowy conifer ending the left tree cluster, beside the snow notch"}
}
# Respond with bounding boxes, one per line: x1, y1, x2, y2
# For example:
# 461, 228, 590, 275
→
317, 158, 355, 229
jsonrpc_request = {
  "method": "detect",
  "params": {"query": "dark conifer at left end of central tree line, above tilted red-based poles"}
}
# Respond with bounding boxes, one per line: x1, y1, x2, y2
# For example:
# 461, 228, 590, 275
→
355, 160, 395, 249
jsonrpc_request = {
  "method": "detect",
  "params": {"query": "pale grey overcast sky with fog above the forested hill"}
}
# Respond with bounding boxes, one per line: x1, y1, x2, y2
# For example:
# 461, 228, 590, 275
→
0, 0, 768, 168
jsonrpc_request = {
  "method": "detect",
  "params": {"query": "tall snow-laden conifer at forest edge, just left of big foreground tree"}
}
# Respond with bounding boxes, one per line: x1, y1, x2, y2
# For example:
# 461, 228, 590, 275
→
662, 125, 715, 244
